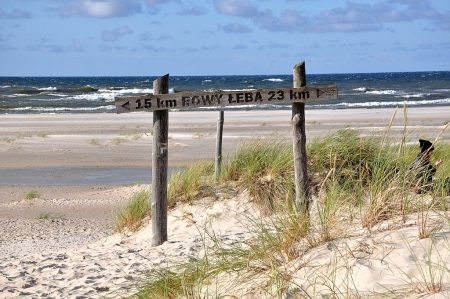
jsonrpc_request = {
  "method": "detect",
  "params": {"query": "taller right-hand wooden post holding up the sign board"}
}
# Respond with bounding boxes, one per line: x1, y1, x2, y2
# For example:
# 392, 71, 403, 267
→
292, 61, 310, 212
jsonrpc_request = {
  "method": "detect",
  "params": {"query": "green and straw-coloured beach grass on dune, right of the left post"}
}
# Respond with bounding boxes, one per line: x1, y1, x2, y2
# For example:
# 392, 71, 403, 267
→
137, 128, 450, 298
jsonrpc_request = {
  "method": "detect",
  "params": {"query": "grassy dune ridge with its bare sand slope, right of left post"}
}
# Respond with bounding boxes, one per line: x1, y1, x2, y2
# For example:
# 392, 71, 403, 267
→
118, 130, 450, 298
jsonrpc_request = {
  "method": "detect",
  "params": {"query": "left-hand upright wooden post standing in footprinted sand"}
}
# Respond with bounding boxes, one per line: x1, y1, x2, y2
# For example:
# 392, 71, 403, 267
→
151, 74, 169, 246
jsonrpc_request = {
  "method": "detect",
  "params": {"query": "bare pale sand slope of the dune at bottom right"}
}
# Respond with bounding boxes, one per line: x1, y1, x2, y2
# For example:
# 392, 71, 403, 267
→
292, 213, 450, 298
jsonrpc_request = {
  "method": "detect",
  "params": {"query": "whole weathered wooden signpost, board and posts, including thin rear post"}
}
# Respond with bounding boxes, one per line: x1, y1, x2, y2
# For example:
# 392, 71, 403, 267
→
115, 62, 338, 246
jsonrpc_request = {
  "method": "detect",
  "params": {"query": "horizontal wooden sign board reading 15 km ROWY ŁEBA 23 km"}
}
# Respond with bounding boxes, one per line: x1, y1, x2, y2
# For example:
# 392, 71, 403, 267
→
115, 84, 338, 113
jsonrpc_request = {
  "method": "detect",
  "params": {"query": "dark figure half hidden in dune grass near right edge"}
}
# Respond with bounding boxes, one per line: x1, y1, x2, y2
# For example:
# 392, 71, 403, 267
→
411, 139, 442, 193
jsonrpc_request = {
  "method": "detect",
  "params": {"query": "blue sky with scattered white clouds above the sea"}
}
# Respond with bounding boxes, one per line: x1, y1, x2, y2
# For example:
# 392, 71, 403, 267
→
0, 0, 450, 76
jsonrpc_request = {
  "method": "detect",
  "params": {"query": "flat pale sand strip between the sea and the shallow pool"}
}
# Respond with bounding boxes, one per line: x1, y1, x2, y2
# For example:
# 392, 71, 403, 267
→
0, 106, 450, 168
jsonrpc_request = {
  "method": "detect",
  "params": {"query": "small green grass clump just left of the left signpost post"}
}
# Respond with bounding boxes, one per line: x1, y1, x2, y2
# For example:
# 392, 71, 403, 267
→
116, 190, 150, 232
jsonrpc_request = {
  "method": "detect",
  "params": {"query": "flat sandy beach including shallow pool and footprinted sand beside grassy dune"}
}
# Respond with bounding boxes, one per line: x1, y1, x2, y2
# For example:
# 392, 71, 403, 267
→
0, 107, 450, 298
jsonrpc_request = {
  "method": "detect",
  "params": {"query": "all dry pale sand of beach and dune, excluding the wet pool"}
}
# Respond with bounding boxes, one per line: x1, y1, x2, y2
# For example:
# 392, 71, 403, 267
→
0, 107, 450, 298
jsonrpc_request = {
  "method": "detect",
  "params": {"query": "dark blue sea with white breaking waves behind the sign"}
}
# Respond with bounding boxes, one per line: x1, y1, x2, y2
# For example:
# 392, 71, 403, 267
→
0, 71, 450, 114
